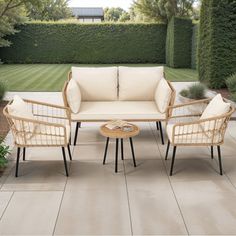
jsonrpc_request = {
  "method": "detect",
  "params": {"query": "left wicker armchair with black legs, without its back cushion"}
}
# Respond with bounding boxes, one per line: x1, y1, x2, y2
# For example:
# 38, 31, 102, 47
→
3, 100, 72, 177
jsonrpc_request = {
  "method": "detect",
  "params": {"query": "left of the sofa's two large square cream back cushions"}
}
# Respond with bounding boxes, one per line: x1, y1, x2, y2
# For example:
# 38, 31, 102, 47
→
72, 67, 117, 101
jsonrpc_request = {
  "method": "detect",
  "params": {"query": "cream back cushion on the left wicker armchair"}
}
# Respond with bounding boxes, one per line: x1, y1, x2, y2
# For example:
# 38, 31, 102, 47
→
7, 95, 35, 132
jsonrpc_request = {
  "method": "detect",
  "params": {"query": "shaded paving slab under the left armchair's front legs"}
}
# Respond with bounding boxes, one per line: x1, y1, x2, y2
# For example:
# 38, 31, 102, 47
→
1, 161, 67, 191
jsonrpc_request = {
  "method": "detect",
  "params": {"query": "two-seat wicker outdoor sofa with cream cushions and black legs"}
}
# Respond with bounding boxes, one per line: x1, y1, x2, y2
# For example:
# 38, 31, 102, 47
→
62, 66, 175, 145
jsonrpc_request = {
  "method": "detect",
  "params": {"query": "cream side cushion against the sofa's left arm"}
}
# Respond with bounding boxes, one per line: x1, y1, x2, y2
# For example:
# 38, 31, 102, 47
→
66, 79, 81, 113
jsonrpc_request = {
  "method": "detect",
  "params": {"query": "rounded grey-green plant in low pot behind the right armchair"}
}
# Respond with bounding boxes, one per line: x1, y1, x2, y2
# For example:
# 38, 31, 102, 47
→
179, 83, 207, 103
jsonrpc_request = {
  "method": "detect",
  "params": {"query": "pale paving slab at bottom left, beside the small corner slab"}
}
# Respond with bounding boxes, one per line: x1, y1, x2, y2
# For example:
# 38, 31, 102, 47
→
0, 191, 62, 235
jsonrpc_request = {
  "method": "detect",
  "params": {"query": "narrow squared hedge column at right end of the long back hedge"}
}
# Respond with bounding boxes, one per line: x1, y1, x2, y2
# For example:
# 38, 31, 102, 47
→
166, 17, 192, 68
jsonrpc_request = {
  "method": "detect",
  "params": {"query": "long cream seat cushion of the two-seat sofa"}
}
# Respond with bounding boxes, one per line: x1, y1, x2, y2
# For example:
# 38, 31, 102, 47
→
71, 101, 166, 121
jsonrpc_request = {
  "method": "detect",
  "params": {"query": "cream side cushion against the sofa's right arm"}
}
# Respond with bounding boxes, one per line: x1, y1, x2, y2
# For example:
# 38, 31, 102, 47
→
155, 78, 172, 113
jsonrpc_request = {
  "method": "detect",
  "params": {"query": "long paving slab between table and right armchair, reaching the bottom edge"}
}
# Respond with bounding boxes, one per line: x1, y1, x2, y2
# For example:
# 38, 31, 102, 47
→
126, 160, 187, 235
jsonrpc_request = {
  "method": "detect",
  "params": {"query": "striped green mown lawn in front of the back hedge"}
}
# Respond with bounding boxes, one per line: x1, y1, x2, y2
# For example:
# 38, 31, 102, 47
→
0, 64, 197, 92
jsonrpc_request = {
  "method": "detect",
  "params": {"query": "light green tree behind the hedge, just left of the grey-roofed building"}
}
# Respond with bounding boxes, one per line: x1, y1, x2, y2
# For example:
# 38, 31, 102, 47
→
27, 0, 72, 21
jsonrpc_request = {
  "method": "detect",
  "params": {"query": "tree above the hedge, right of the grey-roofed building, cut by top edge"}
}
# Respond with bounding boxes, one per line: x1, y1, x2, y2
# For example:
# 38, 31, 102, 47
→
134, 0, 196, 23
